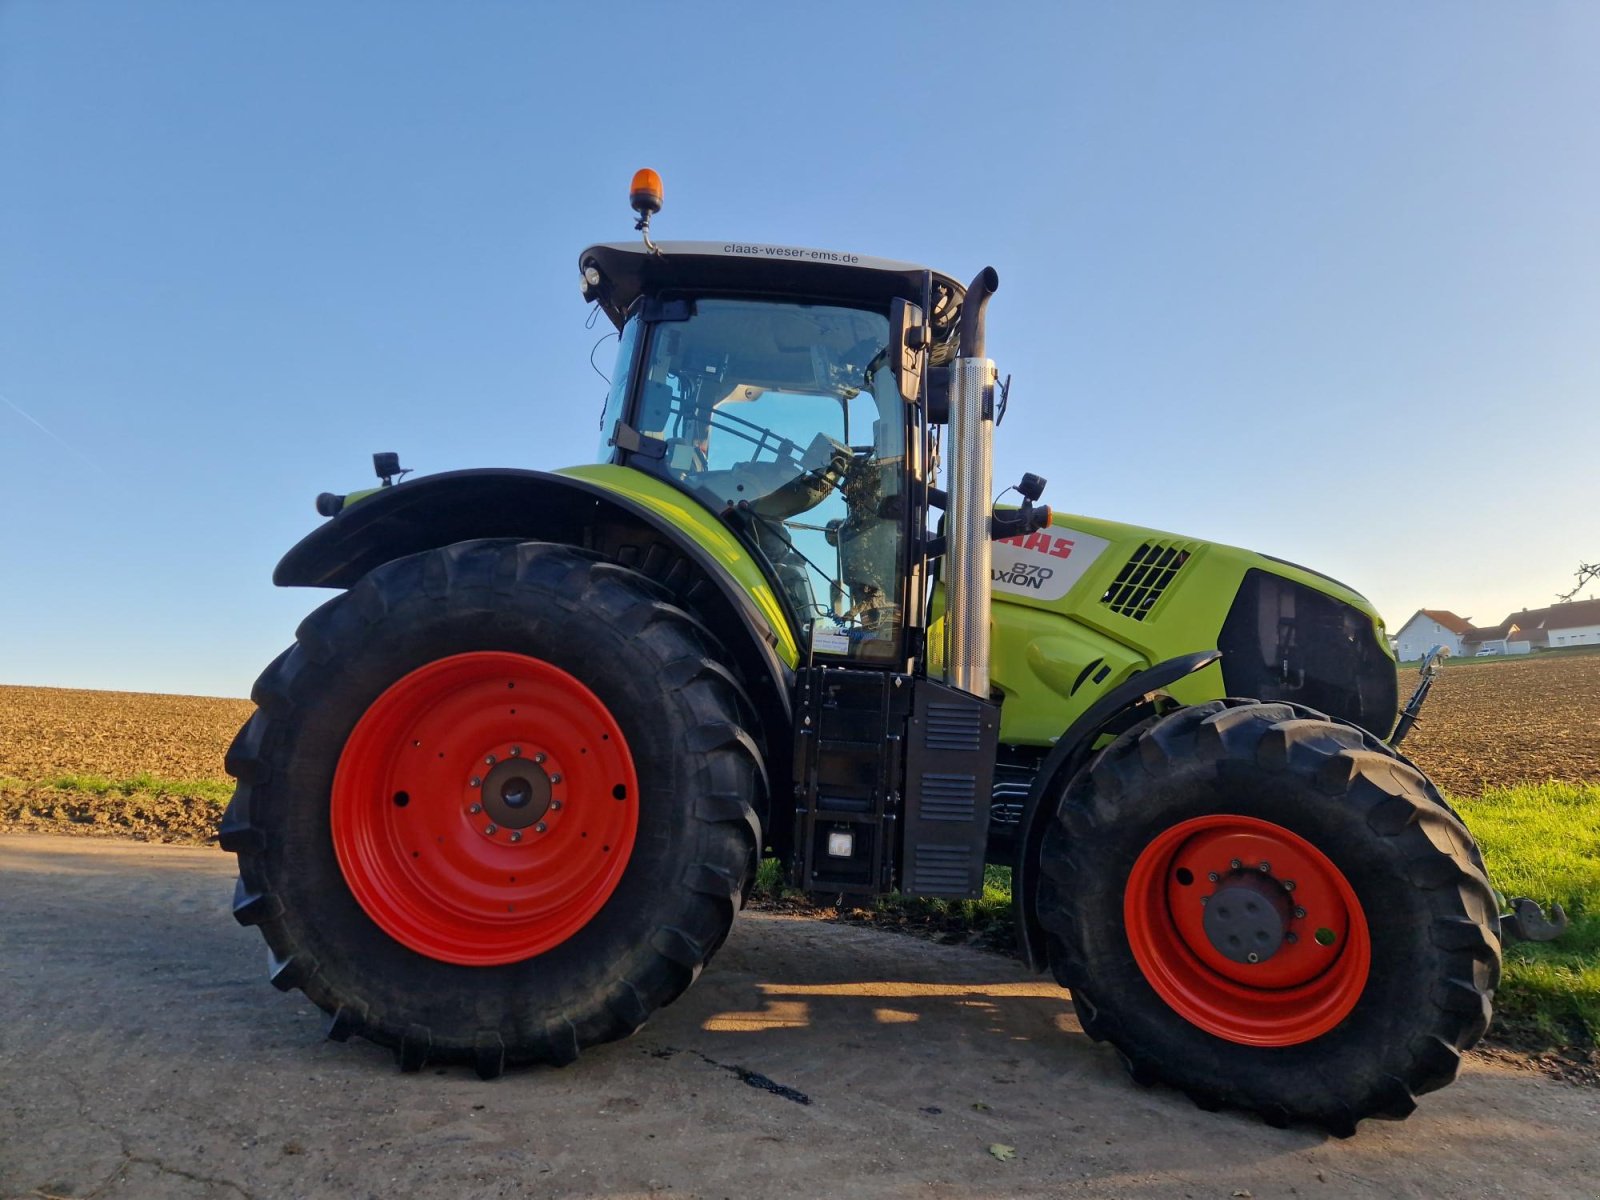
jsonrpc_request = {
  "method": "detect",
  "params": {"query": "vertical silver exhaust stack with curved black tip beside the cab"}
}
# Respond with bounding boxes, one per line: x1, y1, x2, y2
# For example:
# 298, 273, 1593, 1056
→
944, 267, 1000, 699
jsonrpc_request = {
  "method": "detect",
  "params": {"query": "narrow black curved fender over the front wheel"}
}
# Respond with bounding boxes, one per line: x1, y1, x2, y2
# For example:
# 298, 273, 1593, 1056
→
1011, 650, 1222, 971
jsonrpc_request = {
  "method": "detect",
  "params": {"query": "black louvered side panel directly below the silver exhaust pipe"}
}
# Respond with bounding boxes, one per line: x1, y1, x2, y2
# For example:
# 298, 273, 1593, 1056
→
901, 680, 1000, 899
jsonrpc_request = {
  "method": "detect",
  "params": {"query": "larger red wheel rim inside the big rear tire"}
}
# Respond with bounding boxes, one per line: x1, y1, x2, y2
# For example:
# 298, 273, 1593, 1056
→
331, 651, 638, 966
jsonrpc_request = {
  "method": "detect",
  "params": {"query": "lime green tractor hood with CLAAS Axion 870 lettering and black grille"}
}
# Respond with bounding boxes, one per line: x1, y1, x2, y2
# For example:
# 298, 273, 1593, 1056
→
960, 514, 1397, 744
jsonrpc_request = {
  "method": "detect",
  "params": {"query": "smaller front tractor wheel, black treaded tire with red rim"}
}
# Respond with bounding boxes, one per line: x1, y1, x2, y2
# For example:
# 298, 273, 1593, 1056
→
1038, 701, 1501, 1136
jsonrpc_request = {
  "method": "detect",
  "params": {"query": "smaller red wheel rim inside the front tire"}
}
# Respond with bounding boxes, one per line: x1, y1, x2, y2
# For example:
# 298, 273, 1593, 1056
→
1123, 814, 1371, 1046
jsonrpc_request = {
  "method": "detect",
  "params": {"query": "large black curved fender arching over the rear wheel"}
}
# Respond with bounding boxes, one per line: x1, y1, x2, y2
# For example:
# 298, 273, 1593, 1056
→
272, 467, 794, 834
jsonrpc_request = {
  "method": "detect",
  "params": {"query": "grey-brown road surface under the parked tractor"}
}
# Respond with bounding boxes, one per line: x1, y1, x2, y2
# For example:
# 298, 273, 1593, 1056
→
0, 835, 1600, 1200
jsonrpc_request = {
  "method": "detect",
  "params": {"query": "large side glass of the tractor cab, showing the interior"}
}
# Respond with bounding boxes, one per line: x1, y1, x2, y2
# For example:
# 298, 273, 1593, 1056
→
634, 299, 906, 659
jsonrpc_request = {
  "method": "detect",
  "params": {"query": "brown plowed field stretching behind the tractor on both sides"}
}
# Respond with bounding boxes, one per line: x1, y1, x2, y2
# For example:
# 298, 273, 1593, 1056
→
0, 654, 1600, 842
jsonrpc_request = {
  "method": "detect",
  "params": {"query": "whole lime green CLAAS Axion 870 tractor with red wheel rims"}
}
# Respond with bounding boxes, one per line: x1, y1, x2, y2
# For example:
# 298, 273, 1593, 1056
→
221, 173, 1501, 1134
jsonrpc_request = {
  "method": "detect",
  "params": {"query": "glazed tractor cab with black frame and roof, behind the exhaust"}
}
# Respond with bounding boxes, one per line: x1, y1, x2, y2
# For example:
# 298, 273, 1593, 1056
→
579, 242, 963, 664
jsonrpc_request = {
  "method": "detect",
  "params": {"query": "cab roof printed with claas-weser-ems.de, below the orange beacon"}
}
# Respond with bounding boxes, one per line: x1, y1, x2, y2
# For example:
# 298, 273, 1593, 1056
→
578, 242, 966, 341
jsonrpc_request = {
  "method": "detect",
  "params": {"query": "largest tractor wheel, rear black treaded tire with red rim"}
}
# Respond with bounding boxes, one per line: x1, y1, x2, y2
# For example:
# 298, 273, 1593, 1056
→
221, 542, 766, 1077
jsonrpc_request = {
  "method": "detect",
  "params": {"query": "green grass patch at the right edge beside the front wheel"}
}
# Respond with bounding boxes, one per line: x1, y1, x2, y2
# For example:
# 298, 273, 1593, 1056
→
1456, 782, 1600, 1045
